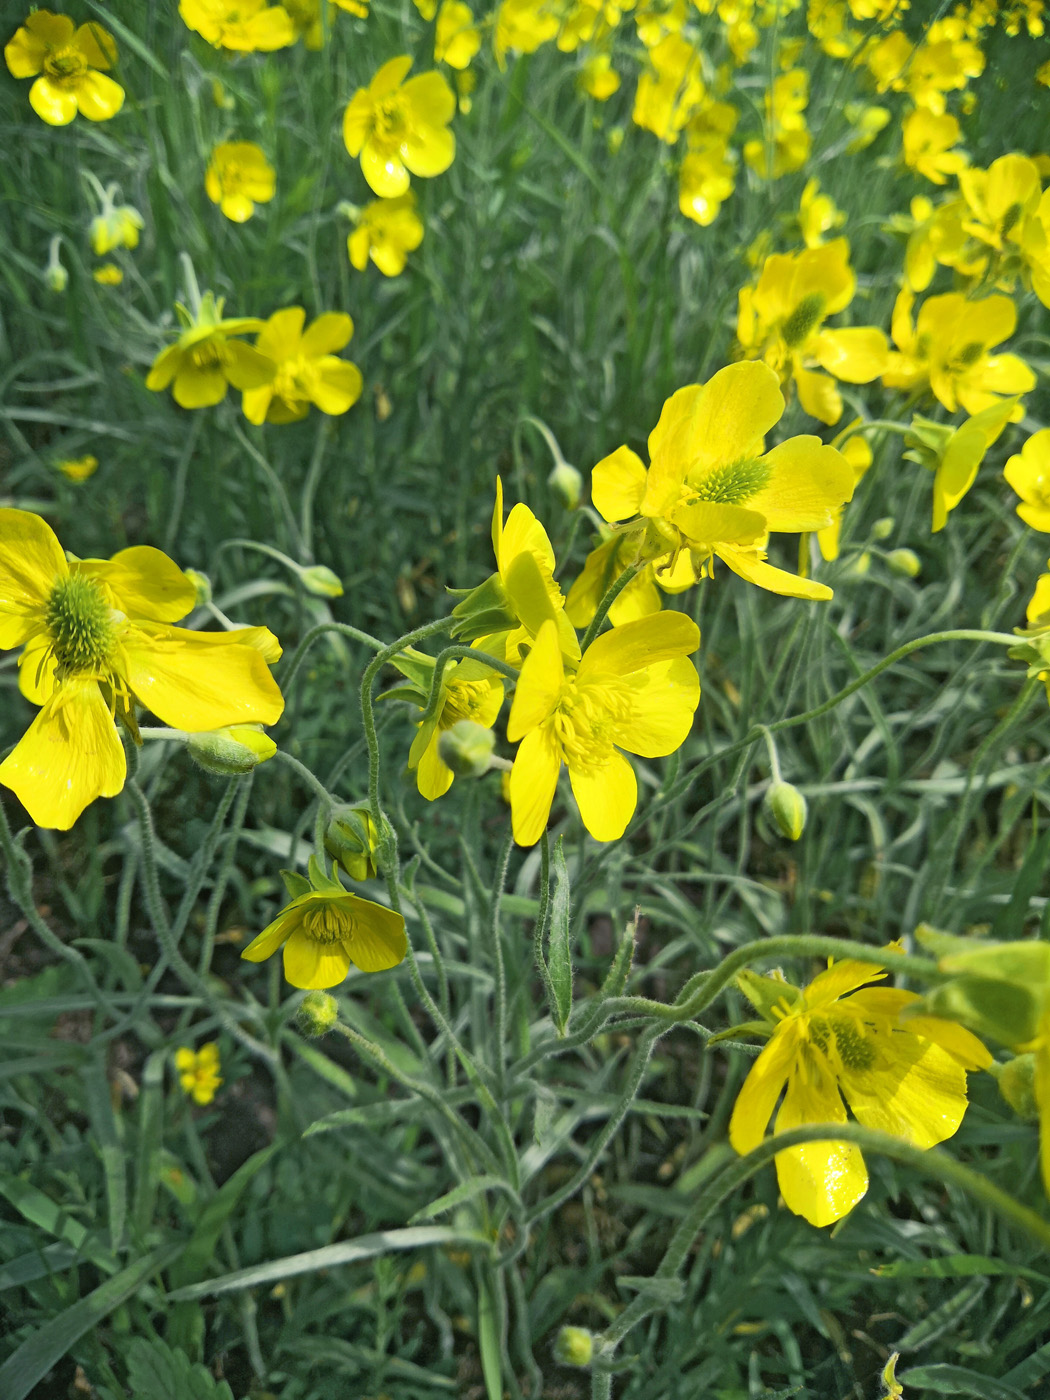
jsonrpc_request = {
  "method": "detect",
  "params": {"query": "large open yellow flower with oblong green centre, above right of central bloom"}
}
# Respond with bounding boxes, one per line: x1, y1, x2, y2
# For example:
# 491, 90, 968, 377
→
591, 361, 853, 599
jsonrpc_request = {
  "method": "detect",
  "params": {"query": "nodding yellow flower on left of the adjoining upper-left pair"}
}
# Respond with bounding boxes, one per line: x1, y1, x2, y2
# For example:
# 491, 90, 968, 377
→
146, 291, 277, 409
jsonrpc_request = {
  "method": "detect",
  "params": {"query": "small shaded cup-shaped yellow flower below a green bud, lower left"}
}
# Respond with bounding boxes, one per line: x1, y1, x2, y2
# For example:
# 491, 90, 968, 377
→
241, 857, 409, 991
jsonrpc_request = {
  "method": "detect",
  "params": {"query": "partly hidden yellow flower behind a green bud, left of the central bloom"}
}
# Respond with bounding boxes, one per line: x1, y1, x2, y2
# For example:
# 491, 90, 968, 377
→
393, 647, 503, 802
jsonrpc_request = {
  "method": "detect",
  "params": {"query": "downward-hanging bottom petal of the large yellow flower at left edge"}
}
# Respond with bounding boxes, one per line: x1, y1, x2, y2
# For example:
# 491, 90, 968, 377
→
0, 680, 127, 832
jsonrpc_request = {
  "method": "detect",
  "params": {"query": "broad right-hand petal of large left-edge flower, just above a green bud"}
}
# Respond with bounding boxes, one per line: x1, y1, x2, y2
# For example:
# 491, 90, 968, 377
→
120, 624, 284, 732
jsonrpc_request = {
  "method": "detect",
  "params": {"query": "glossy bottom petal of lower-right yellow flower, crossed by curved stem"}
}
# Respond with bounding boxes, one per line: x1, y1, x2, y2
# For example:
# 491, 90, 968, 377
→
776, 1074, 868, 1226
